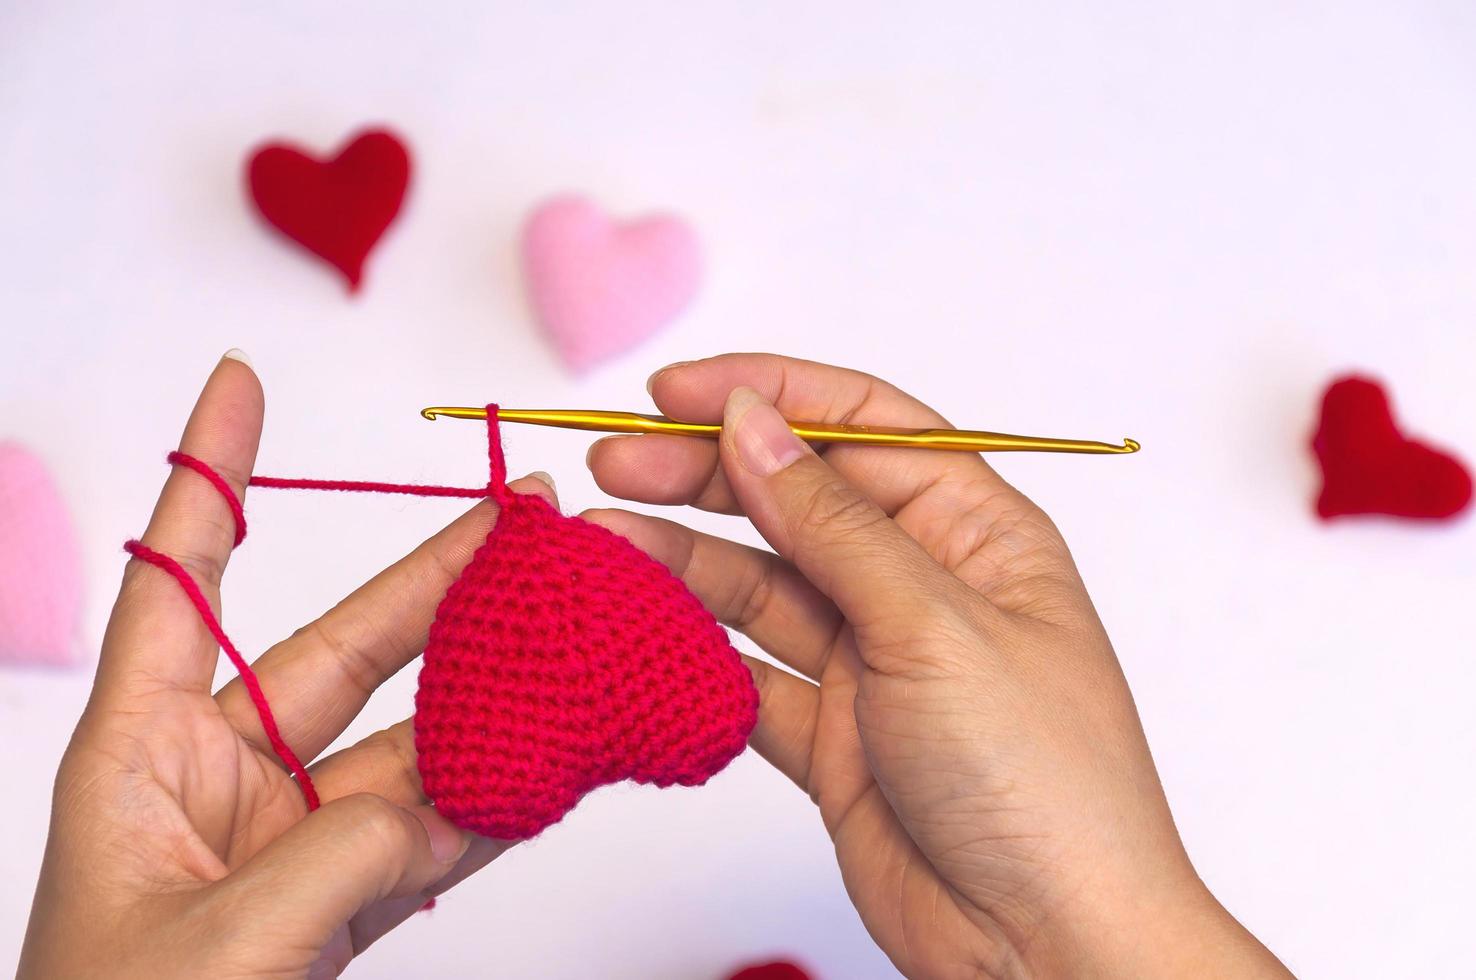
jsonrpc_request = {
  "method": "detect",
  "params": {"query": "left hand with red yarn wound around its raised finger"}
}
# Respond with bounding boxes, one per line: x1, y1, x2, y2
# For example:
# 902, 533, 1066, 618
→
19, 359, 552, 977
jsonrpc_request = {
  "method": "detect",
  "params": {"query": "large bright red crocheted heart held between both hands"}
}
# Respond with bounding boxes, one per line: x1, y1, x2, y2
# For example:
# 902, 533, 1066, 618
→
415, 407, 759, 840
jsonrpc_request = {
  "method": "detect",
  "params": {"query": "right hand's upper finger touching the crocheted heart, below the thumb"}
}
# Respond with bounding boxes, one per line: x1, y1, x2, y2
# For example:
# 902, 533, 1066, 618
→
582, 509, 844, 679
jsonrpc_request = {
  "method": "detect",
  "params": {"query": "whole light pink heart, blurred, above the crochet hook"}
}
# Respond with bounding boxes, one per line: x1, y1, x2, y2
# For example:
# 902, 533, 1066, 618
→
523, 196, 701, 372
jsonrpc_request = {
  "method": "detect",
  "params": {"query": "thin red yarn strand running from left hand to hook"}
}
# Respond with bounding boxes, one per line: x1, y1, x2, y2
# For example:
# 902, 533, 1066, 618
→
123, 404, 508, 808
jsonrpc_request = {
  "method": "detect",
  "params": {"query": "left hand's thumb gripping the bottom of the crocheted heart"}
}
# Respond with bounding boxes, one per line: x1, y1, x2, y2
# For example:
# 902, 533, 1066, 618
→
211, 793, 471, 962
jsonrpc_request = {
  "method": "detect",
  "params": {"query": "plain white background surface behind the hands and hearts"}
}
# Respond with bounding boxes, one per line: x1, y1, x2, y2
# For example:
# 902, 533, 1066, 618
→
0, 0, 1476, 980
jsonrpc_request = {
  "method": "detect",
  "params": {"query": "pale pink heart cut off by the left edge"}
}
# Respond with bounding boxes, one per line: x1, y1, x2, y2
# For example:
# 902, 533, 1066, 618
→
0, 443, 83, 667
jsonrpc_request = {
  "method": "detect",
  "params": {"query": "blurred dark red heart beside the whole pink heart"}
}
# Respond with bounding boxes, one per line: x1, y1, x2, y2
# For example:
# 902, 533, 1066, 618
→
246, 130, 410, 292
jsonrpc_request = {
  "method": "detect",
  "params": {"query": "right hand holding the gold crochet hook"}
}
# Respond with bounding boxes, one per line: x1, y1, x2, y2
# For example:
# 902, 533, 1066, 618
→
586, 354, 1286, 977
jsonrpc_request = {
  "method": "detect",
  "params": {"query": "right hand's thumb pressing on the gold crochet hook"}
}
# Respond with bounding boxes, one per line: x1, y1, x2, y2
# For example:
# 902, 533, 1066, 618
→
720, 388, 987, 673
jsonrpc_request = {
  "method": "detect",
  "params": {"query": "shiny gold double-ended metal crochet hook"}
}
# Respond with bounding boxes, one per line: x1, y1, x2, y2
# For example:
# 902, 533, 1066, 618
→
421, 406, 1141, 455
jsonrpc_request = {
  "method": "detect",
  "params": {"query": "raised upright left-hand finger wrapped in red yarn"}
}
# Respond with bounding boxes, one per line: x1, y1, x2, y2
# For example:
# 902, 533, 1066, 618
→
97, 351, 264, 694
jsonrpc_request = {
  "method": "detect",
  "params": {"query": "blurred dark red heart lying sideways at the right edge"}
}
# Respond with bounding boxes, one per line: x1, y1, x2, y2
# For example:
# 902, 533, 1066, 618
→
1312, 376, 1472, 520
